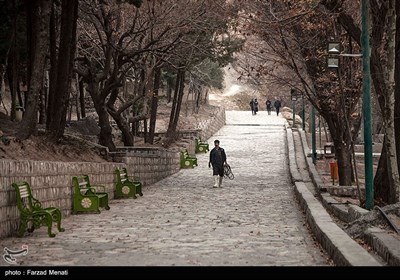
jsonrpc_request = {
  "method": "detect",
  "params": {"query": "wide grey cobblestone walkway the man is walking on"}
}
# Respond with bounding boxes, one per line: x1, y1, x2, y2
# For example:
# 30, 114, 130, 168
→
0, 112, 329, 266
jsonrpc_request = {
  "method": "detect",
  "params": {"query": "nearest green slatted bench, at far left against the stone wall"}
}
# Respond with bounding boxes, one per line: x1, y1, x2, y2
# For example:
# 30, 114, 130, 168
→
12, 181, 64, 237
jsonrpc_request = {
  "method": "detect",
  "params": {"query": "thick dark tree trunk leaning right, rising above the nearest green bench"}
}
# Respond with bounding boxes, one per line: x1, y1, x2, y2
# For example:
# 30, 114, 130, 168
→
16, 0, 52, 140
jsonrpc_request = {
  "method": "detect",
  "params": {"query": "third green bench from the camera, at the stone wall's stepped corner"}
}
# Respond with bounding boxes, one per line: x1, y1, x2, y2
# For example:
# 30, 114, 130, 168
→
115, 168, 143, 198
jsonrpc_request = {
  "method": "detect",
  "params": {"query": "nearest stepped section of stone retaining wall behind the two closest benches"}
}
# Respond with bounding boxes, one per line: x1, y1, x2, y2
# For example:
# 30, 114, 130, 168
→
0, 160, 119, 237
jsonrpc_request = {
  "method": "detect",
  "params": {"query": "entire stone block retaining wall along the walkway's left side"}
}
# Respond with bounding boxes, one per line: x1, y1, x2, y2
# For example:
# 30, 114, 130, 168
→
0, 108, 225, 238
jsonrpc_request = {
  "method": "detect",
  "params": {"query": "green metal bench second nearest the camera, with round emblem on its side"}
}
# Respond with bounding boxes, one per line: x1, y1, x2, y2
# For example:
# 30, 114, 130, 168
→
72, 175, 110, 214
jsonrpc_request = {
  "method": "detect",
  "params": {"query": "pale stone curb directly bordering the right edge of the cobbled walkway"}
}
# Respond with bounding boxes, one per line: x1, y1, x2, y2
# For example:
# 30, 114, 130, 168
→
286, 126, 381, 266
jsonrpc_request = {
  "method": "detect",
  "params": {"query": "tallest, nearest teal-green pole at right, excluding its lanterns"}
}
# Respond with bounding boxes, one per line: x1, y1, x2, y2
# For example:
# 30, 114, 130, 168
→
361, 0, 374, 210
